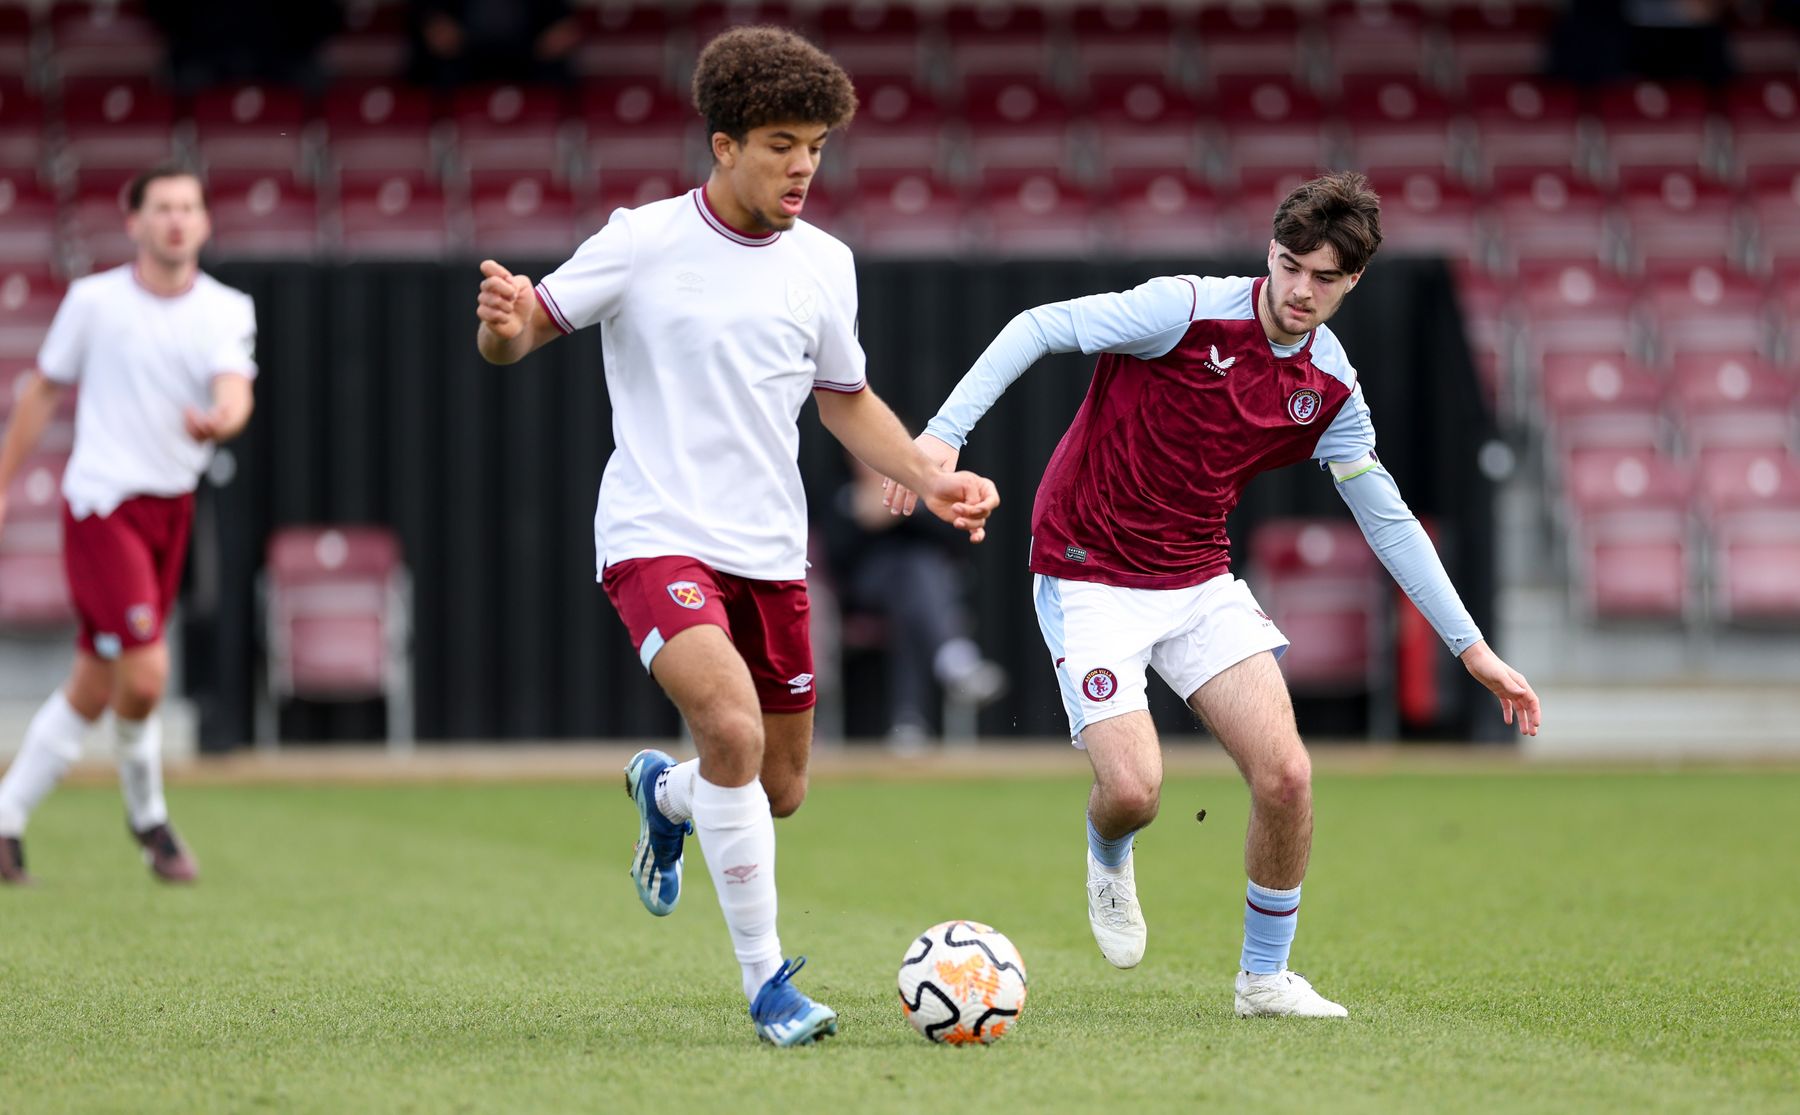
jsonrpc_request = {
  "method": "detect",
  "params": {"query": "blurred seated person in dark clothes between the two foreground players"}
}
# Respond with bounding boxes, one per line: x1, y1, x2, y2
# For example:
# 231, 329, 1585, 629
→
826, 448, 1006, 744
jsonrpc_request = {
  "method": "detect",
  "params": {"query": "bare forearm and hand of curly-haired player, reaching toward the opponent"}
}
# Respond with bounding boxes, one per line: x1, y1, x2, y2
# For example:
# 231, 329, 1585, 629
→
814, 389, 1001, 542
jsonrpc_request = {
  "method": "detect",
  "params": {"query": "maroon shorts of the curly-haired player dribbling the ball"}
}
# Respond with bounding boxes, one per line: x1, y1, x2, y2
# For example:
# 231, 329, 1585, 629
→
599, 557, 815, 712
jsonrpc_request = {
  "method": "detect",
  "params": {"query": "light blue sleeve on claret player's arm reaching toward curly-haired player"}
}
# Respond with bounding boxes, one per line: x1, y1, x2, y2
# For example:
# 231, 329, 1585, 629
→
925, 276, 1197, 449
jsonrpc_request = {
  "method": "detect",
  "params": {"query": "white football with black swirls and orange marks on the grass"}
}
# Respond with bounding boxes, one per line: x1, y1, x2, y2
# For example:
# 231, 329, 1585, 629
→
900, 920, 1026, 1045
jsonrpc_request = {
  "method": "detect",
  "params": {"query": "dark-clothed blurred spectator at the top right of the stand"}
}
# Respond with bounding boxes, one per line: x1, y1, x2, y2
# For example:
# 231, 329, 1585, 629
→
1550, 0, 1733, 85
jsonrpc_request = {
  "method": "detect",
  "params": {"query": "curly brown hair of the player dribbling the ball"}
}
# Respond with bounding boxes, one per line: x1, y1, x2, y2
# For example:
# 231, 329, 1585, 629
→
693, 27, 857, 142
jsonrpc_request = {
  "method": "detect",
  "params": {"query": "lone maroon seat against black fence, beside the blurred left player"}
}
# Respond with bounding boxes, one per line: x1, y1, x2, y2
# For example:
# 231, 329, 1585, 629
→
257, 526, 412, 749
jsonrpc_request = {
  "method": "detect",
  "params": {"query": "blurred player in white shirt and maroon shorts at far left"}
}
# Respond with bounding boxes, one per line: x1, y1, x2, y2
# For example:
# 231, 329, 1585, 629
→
0, 164, 256, 883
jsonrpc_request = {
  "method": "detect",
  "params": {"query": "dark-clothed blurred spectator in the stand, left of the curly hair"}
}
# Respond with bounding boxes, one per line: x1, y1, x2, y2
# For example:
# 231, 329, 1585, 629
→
412, 0, 581, 86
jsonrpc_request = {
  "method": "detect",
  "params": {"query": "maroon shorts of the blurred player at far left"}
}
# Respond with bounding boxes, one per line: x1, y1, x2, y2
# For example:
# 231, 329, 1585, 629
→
63, 494, 194, 659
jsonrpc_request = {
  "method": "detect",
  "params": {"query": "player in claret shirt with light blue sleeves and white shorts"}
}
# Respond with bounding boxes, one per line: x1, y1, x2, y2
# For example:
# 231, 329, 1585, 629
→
889, 173, 1539, 1018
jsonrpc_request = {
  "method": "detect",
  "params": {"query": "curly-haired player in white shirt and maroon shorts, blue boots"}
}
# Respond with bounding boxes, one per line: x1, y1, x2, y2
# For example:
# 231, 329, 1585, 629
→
477, 27, 999, 1045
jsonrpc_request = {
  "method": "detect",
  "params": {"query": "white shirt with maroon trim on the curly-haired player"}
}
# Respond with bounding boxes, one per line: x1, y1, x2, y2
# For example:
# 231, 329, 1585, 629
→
536, 189, 868, 580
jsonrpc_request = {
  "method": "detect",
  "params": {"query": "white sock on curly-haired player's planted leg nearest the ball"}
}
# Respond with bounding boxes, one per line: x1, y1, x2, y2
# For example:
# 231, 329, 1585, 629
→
693, 773, 781, 1000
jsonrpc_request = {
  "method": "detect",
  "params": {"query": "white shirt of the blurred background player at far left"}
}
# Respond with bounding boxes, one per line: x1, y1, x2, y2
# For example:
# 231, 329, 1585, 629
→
38, 263, 256, 519
